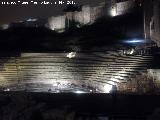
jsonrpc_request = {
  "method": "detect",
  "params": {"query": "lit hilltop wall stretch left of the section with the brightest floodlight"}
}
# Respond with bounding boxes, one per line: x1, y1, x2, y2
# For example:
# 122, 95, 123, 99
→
48, 5, 103, 31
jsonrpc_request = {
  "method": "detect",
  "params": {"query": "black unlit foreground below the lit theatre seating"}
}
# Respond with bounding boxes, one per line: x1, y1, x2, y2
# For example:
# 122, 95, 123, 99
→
0, 92, 160, 120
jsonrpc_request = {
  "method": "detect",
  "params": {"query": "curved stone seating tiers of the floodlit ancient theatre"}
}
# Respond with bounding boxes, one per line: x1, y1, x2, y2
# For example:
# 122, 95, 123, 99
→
0, 51, 152, 92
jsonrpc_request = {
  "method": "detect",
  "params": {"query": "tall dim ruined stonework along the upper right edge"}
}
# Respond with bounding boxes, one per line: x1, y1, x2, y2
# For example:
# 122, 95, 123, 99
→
144, 0, 160, 47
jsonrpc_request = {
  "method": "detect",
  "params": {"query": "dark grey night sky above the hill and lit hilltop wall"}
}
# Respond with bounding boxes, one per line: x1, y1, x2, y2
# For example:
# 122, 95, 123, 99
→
0, 0, 104, 24
